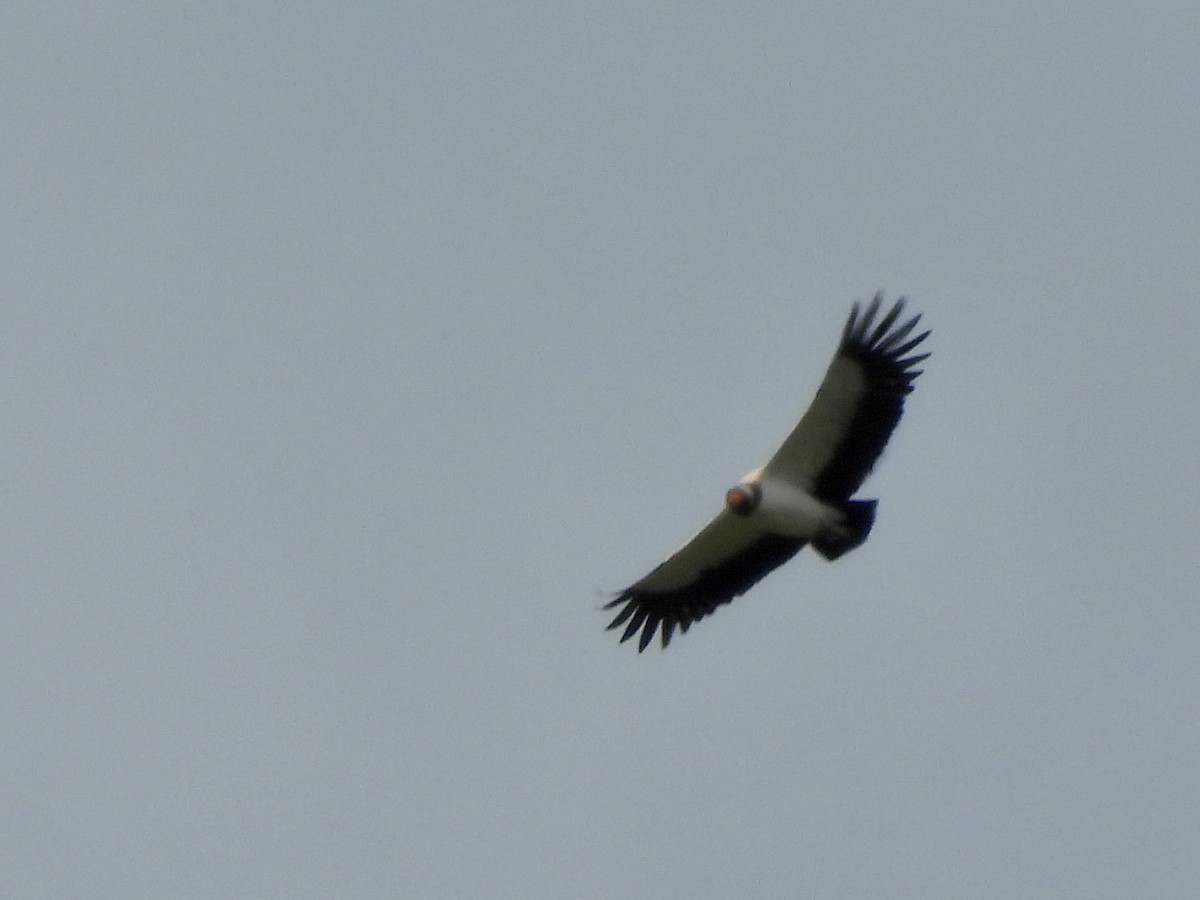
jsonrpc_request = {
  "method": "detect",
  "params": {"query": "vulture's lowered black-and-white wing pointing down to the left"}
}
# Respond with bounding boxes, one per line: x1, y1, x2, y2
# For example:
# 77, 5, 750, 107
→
605, 510, 805, 652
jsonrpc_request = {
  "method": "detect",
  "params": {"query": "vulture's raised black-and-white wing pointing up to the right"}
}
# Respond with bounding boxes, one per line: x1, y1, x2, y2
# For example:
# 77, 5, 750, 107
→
763, 294, 929, 502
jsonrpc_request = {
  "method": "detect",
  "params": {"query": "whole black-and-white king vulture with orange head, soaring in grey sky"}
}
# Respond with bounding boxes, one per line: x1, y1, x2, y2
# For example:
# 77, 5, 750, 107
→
605, 294, 929, 652
